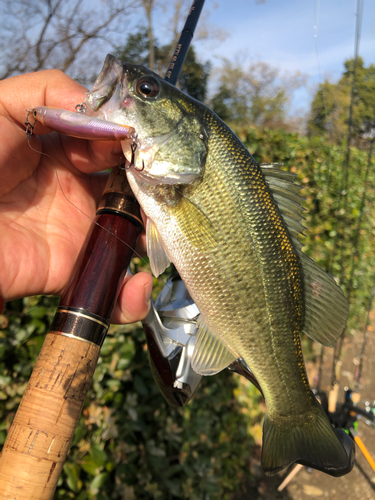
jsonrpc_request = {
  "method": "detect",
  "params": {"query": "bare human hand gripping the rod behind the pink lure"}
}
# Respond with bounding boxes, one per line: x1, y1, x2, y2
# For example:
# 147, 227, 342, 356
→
0, 70, 152, 323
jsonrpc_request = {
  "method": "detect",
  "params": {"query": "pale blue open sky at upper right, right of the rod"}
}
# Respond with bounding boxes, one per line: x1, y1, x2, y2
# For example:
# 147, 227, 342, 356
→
154, 0, 375, 115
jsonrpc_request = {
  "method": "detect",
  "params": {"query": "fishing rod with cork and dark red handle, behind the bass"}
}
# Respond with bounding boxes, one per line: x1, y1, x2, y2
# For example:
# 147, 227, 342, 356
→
0, 0, 204, 500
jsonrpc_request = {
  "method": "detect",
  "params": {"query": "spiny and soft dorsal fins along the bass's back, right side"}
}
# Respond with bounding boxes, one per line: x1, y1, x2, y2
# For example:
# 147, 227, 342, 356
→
260, 165, 349, 347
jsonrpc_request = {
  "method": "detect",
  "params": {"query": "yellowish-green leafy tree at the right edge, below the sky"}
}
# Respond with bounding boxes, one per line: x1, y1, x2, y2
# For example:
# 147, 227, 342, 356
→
308, 57, 375, 144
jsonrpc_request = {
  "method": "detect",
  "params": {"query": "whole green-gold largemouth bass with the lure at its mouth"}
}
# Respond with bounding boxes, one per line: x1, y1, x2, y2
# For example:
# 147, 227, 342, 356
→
86, 56, 354, 475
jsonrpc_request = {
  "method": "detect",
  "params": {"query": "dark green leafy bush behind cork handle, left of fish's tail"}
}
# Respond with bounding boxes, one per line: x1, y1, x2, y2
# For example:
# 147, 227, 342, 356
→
0, 297, 261, 500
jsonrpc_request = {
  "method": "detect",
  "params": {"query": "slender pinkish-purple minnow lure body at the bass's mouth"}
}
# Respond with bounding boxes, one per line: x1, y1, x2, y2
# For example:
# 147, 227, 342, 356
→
27, 106, 137, 141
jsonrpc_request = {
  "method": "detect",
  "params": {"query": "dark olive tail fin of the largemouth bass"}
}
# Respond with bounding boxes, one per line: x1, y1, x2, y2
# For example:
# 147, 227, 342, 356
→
262, 402, 354, 477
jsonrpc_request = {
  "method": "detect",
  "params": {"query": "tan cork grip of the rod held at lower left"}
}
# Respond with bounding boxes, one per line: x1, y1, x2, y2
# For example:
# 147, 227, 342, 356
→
0, 333, 100, 500
